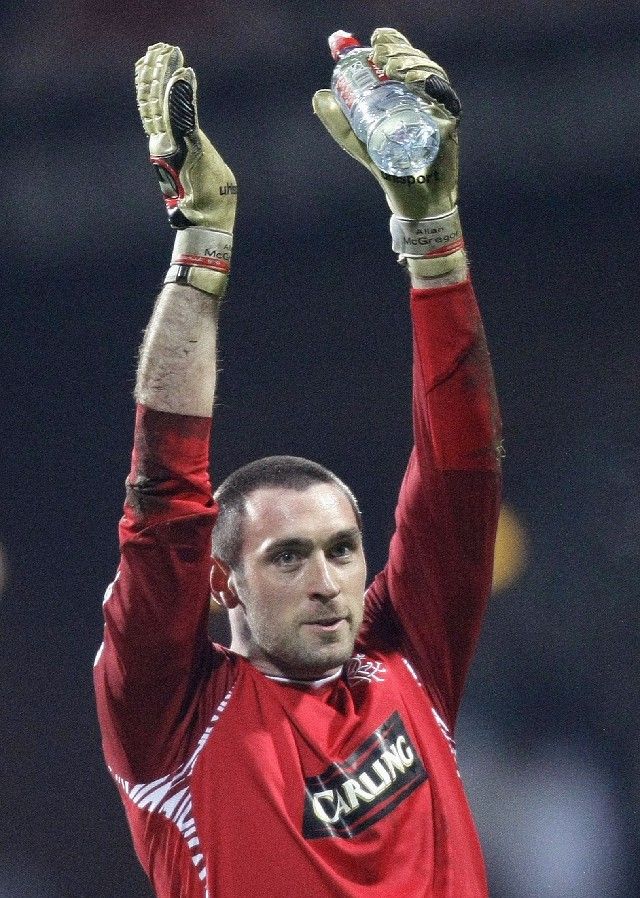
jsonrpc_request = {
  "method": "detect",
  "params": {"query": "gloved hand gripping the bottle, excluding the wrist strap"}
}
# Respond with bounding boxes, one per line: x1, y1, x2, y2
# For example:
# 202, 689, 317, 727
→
313, 28, 460, 219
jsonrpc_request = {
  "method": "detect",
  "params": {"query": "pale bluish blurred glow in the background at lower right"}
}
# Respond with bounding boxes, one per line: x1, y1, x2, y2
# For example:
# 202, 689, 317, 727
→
462, 736, 626, 898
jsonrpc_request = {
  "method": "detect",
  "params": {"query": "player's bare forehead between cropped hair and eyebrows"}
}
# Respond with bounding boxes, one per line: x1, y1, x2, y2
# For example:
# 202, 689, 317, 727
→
243, 483, 357, 552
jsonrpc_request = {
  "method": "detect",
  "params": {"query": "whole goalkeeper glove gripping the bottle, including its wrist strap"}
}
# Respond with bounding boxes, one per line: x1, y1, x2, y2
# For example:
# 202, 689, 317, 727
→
313, 28, 466, 277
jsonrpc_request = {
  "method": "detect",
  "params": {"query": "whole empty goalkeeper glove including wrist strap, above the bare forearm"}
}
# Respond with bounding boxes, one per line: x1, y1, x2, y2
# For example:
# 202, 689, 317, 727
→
135, 43, 237, 295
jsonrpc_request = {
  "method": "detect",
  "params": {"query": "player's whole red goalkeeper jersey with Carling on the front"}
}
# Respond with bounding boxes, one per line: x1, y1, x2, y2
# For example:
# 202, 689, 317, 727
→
95, 282, 499, 898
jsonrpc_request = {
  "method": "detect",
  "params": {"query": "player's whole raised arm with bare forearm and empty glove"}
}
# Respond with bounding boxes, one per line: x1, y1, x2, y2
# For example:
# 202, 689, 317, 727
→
95, 44, 236, 782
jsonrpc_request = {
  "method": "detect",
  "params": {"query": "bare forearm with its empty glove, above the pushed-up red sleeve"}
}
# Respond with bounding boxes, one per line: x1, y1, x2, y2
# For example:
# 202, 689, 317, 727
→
135, 43, 237, 417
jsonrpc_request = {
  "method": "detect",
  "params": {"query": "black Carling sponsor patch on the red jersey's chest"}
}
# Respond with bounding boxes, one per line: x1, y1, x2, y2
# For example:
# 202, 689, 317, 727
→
302, 711, 427, 839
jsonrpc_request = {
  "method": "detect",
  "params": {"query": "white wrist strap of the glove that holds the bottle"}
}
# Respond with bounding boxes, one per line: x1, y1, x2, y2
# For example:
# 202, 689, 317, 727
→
390, 206, 464, 274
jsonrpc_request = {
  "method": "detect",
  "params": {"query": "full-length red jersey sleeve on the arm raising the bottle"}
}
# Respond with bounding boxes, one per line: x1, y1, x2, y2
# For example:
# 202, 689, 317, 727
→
364, 281, 500, 728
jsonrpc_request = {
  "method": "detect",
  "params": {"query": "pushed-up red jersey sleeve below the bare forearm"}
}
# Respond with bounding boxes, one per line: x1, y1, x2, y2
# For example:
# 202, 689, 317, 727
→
94, 406, 222, 782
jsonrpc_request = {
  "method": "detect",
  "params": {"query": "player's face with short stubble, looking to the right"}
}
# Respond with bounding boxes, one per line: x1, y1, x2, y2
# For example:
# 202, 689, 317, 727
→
229, 483, 366, 679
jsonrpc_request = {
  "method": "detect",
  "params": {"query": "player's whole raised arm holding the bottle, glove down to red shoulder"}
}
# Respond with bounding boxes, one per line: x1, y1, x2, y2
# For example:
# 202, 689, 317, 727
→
314, 28, 500, 726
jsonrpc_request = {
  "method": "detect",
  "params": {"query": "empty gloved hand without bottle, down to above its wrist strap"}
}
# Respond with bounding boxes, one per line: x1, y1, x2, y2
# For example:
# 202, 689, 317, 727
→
136, 43, 237, 235
